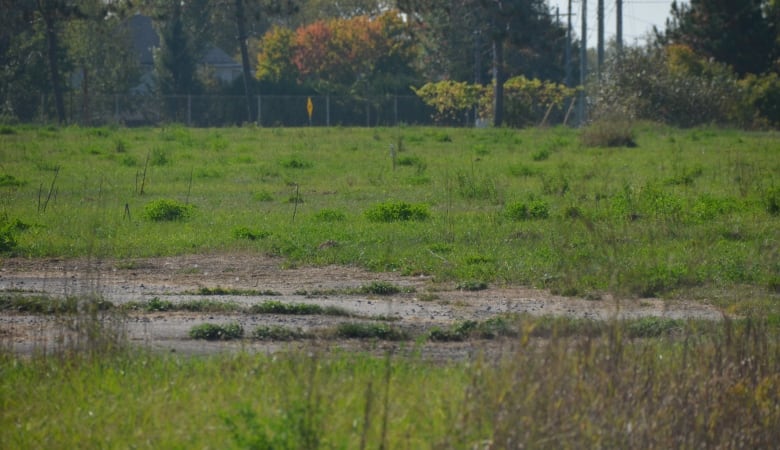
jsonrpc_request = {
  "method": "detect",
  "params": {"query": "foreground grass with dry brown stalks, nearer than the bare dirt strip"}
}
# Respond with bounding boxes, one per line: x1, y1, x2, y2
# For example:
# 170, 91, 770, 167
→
0, 321, 780, 449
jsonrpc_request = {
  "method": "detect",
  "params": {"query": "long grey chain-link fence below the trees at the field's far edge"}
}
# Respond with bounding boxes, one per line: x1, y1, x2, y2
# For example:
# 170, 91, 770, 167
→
47, 95, 450, 127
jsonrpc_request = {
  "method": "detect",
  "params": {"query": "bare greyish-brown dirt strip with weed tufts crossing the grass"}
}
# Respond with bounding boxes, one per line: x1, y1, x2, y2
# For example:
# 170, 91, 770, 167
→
0, 253, 721, 356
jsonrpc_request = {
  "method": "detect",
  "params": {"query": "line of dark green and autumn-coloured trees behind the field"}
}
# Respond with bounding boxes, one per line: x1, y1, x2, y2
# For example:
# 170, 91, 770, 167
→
0, 0, 780, 126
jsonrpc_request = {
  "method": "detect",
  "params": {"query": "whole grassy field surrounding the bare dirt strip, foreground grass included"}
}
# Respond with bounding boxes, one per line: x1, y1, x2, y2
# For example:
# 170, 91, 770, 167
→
0, 124, 780, 449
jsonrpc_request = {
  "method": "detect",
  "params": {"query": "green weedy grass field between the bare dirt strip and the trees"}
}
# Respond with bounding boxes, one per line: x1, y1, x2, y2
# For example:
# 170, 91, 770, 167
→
0, 124, 780, 303
